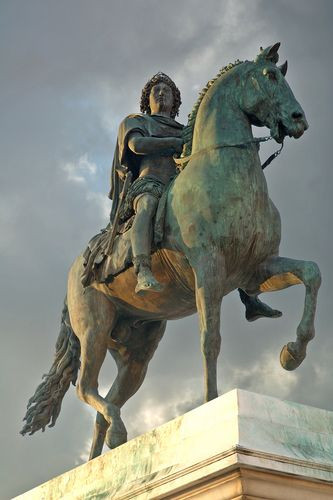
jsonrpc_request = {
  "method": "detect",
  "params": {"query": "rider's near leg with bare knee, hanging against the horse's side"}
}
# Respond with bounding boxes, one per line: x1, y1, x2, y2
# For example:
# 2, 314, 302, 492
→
131, 193, 162, 293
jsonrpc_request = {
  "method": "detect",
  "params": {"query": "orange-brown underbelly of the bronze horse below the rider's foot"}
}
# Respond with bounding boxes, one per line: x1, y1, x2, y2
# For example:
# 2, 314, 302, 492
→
93, 250, 196, 319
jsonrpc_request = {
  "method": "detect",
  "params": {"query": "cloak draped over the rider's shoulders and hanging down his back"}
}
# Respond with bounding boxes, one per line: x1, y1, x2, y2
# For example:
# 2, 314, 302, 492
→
109, 114, 184, 223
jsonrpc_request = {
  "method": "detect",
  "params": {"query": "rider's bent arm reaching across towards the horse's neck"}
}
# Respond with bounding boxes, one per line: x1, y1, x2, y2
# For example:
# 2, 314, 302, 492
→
127, 132, 183, 155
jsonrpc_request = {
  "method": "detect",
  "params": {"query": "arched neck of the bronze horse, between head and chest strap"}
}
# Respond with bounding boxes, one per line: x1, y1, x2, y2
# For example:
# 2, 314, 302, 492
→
192, 75, 253, 153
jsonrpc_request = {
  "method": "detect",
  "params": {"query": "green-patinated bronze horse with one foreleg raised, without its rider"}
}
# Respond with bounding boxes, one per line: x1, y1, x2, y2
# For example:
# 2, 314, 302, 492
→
22, 44, 321, 458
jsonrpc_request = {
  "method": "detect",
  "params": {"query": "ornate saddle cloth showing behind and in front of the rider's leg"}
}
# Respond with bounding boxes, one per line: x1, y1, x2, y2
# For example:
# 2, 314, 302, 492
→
81, 183, 171, 287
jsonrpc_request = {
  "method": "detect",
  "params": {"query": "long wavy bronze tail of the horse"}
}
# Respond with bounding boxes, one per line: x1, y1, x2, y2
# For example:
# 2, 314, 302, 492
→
21, 299, 80, 435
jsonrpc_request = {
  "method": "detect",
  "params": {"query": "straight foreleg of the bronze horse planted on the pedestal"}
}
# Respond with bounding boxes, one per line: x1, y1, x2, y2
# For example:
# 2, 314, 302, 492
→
191, 250, 225, 401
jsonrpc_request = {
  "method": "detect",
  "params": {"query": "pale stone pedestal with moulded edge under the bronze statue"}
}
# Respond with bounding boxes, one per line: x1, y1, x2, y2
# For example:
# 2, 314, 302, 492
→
17, 389, 333, 500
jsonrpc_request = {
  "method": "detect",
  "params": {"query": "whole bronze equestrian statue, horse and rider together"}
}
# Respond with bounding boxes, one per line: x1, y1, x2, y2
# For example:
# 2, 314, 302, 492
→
21, 43, 321, 459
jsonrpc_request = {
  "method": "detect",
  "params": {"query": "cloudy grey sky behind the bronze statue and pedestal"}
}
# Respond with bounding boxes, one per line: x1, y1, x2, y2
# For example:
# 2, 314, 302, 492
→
0, 0, 333, 499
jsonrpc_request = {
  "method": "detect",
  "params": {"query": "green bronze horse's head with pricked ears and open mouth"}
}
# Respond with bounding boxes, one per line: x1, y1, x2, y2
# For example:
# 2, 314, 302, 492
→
241, 43, 308, 143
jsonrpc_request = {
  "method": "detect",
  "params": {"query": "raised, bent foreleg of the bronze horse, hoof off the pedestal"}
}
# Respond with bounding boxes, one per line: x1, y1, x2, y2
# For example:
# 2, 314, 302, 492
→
248, 257, 321, 370
